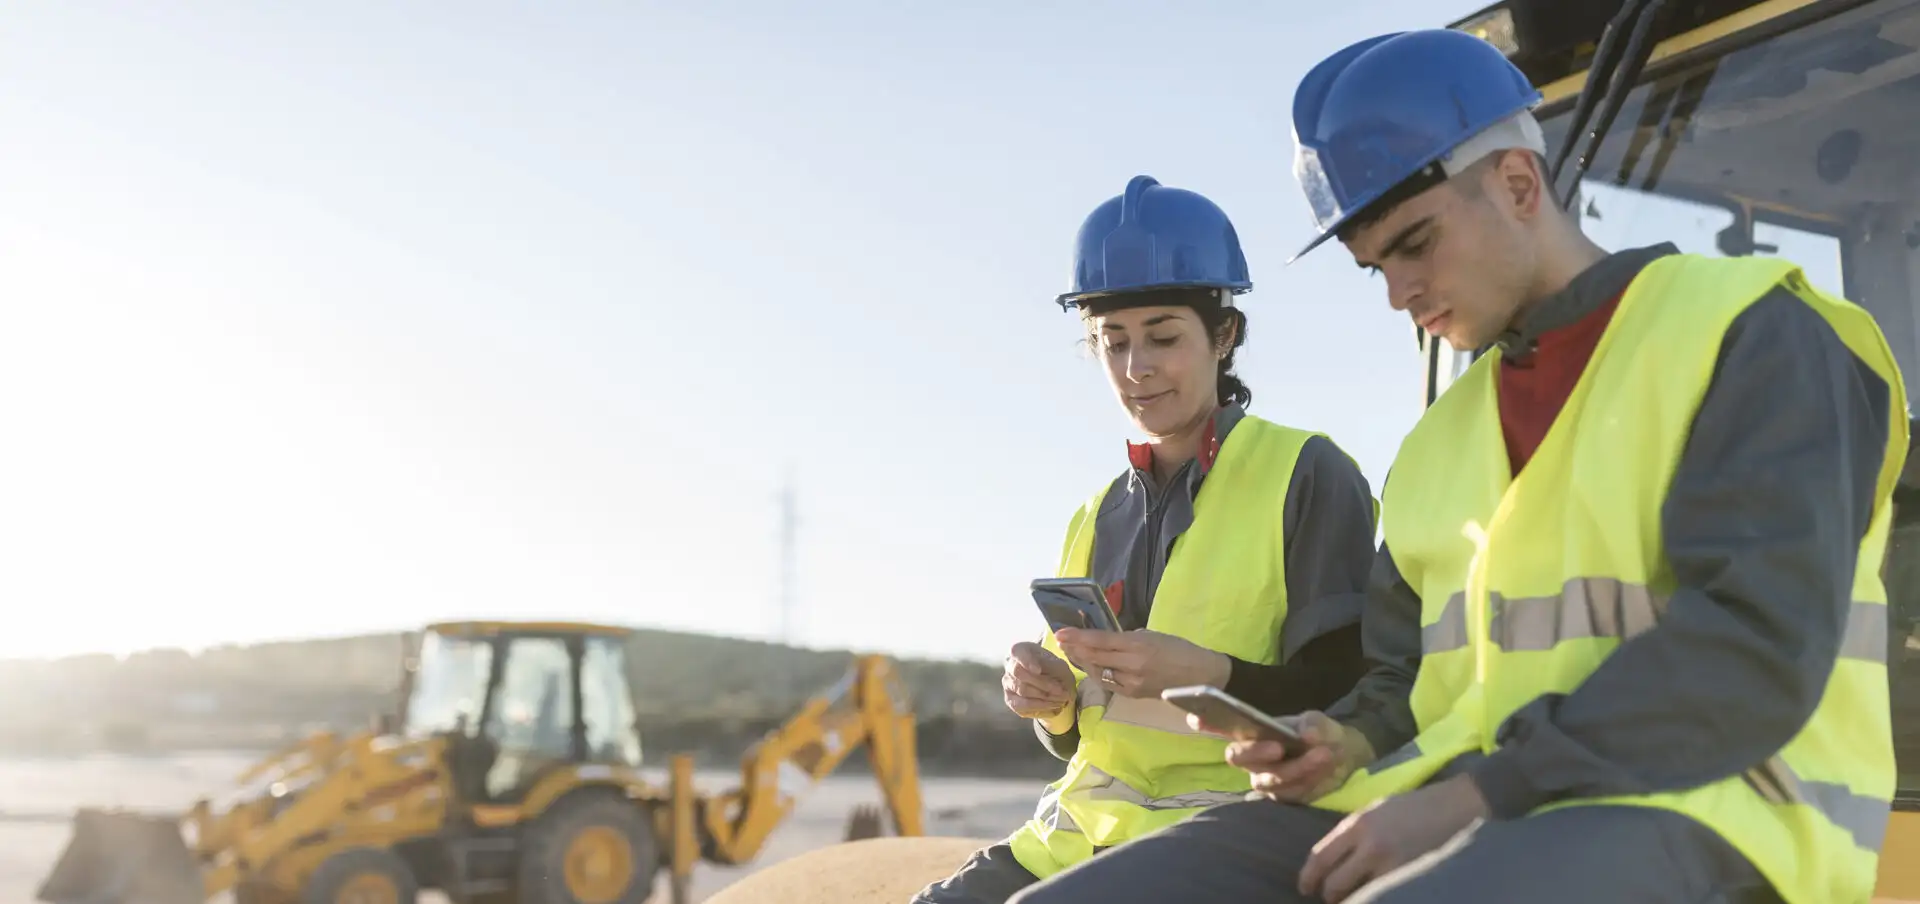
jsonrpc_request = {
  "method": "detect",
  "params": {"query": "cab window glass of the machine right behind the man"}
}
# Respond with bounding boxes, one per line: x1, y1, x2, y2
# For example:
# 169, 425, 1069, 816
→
1512, 0, 1920, 798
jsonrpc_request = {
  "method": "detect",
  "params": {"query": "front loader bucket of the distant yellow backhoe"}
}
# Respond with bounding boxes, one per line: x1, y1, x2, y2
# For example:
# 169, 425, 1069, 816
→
35, 808, 207, 904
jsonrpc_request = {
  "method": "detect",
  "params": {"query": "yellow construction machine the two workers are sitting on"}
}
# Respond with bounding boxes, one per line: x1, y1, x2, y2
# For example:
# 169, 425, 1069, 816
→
714, 0, 1920, 904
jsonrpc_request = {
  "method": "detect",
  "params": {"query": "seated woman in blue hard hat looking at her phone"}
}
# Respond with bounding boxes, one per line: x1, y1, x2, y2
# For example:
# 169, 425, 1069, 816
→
912, 177, 1377, 904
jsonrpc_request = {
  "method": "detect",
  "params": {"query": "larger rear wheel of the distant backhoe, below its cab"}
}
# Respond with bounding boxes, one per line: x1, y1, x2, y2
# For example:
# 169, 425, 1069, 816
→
516, 793, 660, 904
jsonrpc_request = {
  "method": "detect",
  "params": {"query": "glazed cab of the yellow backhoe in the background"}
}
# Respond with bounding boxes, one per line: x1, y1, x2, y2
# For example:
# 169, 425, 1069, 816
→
396, 622, 641, 804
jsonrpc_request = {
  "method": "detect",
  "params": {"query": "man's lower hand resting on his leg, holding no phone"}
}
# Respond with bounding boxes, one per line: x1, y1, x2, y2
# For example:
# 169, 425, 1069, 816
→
1300, 775, 1486, 904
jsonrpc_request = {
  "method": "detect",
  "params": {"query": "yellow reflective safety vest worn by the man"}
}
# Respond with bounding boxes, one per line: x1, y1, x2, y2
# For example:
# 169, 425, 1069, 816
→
1319, 255, 1907, 904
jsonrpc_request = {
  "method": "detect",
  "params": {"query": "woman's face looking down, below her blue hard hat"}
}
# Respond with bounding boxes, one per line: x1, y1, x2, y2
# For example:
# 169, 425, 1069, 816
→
1089, 305, 1219, 438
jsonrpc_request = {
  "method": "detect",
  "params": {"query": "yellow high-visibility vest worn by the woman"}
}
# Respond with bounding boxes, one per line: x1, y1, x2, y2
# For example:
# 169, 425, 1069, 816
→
1008, 415, 1315, 879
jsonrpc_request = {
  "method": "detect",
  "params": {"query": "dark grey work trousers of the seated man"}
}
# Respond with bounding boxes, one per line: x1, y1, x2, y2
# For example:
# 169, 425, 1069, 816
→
1012, 800, 1780, 904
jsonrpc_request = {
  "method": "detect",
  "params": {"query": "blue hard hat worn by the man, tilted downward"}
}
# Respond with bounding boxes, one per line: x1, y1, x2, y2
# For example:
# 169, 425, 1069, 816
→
1288, 29, 1540, 263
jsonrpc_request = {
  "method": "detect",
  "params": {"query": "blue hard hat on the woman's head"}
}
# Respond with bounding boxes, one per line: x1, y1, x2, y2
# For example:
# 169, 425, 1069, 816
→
1058, 177, 1254, 309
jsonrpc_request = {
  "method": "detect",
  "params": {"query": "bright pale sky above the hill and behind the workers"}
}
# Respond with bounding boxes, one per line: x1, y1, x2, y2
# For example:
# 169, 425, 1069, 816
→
0, 0, 1835, 658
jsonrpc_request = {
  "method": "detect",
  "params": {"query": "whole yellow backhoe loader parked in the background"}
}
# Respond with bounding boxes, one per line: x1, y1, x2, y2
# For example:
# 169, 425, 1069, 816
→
38, 622, 922, 904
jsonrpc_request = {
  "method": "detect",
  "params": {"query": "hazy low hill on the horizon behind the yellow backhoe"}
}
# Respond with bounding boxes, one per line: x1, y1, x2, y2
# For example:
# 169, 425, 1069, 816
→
0, 630, 1060, 773
